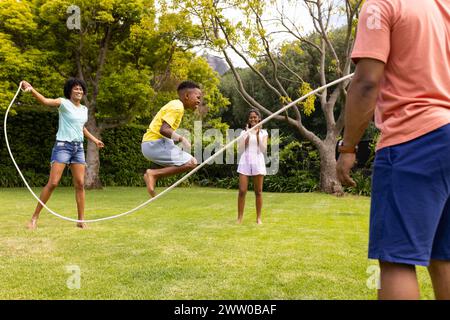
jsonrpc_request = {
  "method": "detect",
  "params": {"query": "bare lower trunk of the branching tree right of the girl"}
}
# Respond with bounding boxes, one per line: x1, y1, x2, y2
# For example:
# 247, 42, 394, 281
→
319, 139, 344, 195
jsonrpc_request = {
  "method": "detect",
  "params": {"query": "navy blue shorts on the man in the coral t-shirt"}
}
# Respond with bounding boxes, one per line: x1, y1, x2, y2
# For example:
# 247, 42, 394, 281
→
369, 124, 450, 266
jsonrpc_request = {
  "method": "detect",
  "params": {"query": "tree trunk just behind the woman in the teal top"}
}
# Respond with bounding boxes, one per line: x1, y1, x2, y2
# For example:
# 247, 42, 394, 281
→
84, 121, 102, 189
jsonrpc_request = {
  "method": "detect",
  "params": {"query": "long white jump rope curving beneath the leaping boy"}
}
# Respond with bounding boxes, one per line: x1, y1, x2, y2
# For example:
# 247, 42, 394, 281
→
4, 73, 353, 223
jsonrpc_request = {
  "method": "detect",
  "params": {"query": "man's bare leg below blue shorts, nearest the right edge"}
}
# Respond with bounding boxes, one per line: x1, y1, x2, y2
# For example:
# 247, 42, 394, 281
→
428, 260, 450, 300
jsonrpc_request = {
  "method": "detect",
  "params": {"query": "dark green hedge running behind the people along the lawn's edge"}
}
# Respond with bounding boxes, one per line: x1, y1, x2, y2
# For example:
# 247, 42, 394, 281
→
0, 108, 371, 195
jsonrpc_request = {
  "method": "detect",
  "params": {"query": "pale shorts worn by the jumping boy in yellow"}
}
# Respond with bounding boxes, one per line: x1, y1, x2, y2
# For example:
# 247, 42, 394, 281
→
141, 138, 193, 167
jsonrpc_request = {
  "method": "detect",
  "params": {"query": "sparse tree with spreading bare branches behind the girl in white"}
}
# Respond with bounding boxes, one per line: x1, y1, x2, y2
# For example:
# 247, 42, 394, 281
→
176, 0, 362, 194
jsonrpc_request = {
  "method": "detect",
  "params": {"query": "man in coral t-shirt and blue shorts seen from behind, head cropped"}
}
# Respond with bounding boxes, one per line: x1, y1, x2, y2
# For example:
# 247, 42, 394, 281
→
337, 0, 450, 299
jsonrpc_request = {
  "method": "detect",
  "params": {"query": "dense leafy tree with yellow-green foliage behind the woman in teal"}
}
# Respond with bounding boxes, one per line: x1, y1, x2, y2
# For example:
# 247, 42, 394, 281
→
0, 0, 227, 188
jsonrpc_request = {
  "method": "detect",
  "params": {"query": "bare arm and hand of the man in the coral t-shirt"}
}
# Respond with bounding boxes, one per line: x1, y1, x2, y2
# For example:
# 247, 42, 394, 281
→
336, 59, 385, 186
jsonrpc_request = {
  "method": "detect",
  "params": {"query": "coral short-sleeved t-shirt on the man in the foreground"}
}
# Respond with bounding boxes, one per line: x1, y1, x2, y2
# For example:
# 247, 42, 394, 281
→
352, 0, 450, 150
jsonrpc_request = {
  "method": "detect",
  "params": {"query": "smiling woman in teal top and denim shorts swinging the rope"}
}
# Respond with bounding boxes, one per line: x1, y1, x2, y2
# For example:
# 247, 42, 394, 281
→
22, 78, 104, 229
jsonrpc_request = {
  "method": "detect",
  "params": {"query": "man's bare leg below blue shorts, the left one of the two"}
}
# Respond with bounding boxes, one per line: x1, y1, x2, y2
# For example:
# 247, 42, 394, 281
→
378, 261, 420, 300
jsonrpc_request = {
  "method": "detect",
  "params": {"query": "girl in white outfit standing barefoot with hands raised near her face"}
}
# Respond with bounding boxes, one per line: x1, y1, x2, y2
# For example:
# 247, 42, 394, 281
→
237, 109, 268, 224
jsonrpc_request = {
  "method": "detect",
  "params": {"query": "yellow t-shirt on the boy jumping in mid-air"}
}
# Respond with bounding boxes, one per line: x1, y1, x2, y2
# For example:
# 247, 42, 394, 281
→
142, 99, 184, 142
